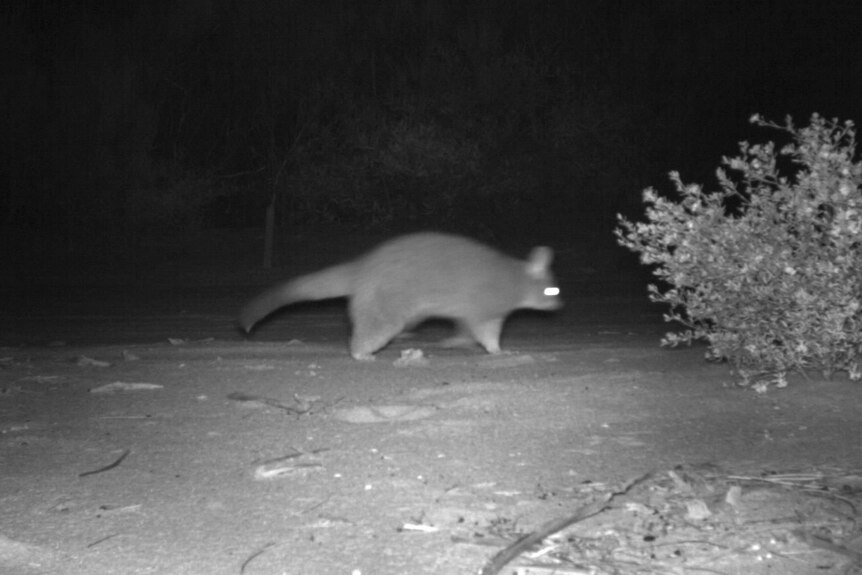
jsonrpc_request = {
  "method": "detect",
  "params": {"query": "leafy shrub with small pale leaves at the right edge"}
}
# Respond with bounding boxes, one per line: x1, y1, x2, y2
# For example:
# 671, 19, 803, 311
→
616, 114, 862, 390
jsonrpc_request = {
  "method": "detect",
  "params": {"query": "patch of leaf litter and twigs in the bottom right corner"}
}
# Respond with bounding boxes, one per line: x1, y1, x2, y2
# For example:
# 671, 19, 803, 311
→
472, 465, 862, 575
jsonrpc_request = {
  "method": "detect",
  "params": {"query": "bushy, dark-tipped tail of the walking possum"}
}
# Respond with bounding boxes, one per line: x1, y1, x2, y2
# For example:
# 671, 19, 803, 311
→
239, 262, 356, 332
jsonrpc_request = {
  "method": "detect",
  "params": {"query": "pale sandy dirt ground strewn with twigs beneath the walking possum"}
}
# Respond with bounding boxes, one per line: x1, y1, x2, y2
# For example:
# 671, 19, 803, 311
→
0, 231, 862, 575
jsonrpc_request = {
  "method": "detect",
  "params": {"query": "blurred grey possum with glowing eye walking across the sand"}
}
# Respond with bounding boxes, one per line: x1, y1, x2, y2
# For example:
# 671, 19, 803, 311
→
239, 233, 562, 360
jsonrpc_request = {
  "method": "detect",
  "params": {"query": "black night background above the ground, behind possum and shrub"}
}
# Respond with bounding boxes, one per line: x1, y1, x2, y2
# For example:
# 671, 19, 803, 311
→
0, 0, 862, 270
